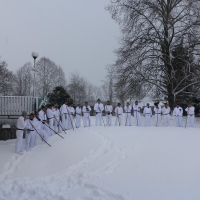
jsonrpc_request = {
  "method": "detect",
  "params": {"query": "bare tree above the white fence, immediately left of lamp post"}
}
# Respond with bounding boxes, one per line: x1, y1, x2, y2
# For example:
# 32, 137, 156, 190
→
14, 62, 33, 96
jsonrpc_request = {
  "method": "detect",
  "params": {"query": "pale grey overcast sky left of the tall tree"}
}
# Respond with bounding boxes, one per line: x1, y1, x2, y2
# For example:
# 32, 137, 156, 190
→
0, 0, 120, 86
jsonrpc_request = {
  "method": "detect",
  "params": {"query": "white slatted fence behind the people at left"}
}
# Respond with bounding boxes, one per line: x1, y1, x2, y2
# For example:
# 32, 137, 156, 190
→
0, 96, 39, 116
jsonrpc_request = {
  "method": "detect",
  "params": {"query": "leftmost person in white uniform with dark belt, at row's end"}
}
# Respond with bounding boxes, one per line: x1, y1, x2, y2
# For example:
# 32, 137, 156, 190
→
15, 111, 27, 154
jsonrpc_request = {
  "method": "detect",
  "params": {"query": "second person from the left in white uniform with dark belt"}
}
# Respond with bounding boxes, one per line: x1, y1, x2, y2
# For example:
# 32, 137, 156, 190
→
25, 113, 37, 151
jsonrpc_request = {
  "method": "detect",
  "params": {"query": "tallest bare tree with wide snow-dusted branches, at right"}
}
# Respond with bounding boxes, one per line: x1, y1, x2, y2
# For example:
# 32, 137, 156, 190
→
107, 0, 200, 107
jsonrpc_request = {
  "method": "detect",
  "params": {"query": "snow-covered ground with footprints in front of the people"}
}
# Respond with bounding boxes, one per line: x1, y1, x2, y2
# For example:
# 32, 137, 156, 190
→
0, 118, 200, 200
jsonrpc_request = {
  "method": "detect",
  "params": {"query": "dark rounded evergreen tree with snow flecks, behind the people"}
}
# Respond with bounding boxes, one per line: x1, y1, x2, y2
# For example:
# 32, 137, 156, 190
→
44, 86, 73, 107
